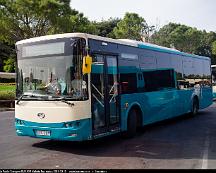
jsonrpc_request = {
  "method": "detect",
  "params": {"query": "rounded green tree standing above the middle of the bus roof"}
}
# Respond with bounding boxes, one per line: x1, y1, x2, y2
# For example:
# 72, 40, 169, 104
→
113, 13, 148, 40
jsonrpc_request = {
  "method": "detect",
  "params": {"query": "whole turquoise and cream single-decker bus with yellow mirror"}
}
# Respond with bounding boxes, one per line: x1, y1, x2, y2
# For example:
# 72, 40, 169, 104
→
15, 33, 212, 141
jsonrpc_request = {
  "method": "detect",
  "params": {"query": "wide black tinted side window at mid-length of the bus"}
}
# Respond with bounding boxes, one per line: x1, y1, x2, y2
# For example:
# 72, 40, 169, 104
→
143, 70, 175, 92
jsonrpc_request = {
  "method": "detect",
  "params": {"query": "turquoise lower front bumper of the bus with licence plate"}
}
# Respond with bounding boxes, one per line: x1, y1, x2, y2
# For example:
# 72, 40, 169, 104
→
15, 119, 92, 141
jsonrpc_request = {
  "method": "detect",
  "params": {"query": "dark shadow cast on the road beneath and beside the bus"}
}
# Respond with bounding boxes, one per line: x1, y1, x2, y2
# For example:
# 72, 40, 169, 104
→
33, 111, 216, 159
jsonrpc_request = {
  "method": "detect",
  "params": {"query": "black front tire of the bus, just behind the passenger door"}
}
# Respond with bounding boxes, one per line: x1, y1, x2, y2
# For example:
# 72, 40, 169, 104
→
126, 109, 137, 138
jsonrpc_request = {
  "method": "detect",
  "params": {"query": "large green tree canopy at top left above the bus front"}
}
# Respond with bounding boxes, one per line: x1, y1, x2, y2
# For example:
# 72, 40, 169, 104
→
0, 0, 96, 43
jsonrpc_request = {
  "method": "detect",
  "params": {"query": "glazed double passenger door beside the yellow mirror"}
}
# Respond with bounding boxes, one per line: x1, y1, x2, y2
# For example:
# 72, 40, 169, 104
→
91, 54, 119, 135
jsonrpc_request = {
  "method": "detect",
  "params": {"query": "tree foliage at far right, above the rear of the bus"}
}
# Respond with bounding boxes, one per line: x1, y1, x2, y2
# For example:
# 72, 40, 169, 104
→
152, 23, 216, 63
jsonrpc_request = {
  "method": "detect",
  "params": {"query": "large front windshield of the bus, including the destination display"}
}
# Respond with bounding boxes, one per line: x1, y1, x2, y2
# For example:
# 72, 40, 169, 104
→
17, 39, 88, 100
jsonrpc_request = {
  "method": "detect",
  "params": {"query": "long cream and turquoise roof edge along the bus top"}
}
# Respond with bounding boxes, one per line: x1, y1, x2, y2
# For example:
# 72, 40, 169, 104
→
16, 33, 210, 60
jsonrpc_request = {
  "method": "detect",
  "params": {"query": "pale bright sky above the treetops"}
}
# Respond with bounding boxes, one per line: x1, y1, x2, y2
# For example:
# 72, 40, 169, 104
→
71, 0, 216, 32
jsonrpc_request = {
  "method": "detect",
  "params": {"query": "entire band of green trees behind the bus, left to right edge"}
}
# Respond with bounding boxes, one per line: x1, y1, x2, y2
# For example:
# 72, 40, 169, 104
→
0, 0, 216, 72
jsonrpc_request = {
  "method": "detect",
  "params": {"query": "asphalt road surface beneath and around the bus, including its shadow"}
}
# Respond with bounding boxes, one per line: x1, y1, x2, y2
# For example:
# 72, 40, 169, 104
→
0, 104, 216, 169
